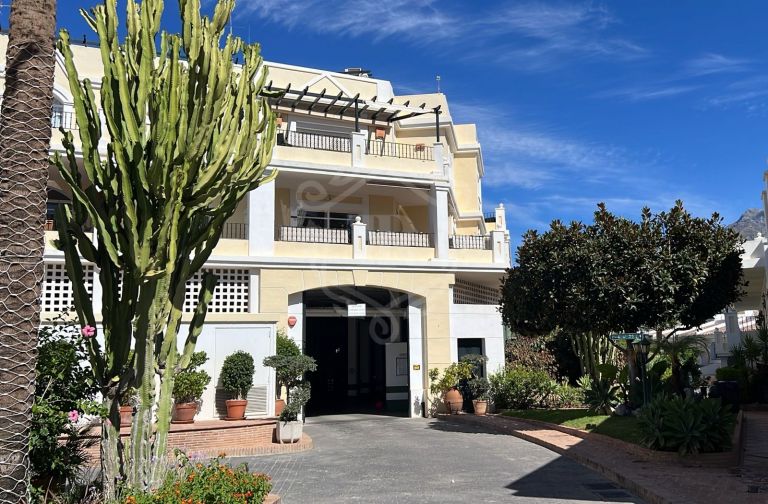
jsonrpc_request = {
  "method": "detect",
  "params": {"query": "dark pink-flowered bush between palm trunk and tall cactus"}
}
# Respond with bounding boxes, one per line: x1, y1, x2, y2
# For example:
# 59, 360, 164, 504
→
29, 321, 101, 500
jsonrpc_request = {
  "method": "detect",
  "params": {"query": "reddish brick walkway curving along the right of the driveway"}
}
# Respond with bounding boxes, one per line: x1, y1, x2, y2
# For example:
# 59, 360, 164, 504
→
445, 413, 768, 504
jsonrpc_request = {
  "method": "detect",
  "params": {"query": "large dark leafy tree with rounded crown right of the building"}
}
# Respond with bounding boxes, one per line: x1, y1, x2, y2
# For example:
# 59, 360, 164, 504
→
501, 201, 743, 378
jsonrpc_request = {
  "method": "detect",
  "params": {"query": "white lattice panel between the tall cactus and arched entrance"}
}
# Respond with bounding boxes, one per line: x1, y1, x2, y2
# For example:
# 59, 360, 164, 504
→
184, 268, 251, 313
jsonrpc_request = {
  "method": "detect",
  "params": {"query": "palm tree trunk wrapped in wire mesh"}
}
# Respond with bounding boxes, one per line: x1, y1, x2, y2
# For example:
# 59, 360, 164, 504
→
0, 0, 56, 504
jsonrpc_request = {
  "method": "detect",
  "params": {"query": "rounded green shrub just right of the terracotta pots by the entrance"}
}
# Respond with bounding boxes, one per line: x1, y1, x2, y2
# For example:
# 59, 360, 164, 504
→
489, 366, 553, 409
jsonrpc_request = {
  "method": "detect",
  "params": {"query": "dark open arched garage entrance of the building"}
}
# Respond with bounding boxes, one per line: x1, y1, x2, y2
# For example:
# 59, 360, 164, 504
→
303, 286, 410, 416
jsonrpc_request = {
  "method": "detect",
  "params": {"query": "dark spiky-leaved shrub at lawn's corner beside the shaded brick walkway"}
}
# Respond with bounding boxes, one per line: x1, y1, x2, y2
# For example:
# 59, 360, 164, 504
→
638, 396, 736, 455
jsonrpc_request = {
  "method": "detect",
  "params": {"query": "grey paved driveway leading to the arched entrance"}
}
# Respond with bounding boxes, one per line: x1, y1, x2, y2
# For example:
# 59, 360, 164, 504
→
236, 417, 642, 504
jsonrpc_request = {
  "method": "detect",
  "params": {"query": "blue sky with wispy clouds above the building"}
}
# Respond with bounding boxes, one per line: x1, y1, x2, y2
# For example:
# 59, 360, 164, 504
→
21, 0, 768, 247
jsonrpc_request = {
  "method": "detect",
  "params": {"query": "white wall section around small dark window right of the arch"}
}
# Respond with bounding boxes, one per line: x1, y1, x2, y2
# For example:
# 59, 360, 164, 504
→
451, 303, 504, 374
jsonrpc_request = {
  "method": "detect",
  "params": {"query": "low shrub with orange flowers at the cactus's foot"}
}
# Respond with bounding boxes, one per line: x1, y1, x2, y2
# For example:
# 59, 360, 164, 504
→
122, 458, 272, 504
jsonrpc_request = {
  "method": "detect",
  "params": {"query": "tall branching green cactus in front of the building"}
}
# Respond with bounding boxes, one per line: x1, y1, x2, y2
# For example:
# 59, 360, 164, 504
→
53, 0, 275, 495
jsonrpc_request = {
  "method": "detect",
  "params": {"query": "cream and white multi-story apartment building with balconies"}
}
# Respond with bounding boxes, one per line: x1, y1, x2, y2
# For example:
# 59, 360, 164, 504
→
10, 37, 510, 418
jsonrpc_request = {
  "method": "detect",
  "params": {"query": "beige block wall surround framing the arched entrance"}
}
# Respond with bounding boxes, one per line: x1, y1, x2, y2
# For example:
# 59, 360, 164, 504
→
259, 269, 455, 370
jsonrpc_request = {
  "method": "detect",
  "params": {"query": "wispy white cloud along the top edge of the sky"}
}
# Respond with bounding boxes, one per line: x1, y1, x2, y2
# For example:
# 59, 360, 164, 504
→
238, 0, 647, 71
